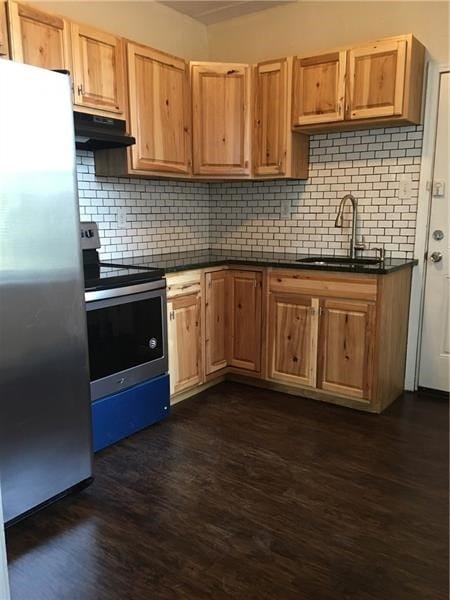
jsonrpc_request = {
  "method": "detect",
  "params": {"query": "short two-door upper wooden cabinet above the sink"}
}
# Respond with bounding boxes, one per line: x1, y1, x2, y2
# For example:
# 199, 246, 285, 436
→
292, 34, 425, 133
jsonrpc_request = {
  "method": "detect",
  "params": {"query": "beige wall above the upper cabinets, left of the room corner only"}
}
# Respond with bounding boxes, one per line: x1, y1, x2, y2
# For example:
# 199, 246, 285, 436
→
33, 0, 208, 60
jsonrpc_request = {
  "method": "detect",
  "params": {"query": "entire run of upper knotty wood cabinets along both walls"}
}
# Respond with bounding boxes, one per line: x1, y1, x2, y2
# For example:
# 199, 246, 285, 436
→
0, 0, 425, 181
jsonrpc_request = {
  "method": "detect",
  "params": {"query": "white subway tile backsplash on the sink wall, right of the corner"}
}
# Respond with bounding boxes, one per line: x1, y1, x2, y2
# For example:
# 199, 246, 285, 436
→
210, 126, 422, 257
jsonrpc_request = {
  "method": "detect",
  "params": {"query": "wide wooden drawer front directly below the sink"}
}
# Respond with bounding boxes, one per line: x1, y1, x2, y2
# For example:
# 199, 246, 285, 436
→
269, 270, 377, 301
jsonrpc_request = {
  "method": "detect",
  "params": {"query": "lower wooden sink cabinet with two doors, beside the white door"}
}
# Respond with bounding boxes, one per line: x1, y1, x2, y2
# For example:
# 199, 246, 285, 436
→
267, 268, 411, 412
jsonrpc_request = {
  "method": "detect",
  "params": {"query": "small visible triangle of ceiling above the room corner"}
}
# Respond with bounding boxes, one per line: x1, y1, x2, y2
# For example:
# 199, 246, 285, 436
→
159, 0, 296, 25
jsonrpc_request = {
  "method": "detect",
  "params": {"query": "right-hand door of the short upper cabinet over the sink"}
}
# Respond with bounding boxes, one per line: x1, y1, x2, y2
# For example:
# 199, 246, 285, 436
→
347, 40, 406, 119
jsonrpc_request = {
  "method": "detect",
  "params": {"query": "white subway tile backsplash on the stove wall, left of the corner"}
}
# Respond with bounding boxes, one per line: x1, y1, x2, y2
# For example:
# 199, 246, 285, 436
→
77, 151, 210, 260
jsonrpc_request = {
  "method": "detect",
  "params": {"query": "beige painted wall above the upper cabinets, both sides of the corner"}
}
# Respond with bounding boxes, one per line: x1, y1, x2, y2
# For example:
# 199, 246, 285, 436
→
30, 0, 450, 63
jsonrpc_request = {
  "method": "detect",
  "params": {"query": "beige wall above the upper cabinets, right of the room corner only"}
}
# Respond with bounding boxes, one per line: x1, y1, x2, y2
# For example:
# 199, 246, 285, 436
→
208, 0, 450, 62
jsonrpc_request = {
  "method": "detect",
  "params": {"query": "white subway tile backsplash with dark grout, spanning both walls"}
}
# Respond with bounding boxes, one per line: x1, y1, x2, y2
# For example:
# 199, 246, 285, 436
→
77, 126, 422, 259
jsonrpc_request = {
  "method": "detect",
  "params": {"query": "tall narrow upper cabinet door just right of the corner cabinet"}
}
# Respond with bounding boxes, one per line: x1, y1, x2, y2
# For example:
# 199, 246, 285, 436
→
253, 59, 289, 175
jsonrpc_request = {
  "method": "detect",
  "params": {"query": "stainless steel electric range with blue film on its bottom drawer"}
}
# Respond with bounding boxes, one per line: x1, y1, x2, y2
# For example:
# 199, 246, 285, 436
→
81, 222, 170, 450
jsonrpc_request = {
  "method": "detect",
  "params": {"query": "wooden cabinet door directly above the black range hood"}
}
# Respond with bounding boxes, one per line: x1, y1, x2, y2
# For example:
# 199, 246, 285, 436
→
71, 23, 125, 115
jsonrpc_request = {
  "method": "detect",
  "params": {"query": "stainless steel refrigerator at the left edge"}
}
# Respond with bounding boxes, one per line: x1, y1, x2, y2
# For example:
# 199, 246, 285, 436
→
0, 60, 92, 522
